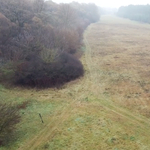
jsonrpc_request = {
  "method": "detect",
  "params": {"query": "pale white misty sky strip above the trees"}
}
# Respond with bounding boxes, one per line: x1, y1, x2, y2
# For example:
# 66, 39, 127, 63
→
52, 0, 150, 8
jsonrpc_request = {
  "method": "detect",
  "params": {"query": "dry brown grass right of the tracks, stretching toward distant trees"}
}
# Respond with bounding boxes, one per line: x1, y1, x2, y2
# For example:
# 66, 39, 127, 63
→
85, 17, 150, 117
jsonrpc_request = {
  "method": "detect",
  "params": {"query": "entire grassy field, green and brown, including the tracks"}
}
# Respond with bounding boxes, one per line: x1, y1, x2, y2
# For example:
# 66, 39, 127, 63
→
0, 16, 150, 150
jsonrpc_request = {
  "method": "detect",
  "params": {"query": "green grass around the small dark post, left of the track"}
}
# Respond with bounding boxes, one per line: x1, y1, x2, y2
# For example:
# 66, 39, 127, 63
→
0, 85, 66, 150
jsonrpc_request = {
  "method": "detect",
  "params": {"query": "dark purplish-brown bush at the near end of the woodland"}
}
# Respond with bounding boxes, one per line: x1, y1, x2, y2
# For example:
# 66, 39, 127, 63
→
15, 52, 84, 88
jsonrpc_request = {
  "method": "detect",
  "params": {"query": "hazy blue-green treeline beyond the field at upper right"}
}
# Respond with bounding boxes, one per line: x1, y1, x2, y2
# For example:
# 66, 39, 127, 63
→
117, 5, 150, 23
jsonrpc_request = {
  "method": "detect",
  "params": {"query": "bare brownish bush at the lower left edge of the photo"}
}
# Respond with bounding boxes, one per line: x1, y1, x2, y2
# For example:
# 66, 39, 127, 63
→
0, 103, 21, 145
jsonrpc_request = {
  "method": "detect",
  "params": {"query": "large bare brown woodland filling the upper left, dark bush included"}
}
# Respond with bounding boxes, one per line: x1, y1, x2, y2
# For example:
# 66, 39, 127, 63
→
0, 0, 99, 87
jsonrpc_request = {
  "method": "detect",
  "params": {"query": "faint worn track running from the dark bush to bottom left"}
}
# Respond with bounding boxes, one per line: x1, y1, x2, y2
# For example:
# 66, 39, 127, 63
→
18, 68, 88, 150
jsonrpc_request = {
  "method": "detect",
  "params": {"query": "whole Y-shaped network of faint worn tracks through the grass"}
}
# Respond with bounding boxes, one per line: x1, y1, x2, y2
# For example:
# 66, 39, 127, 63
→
19, 15, 150, 150
